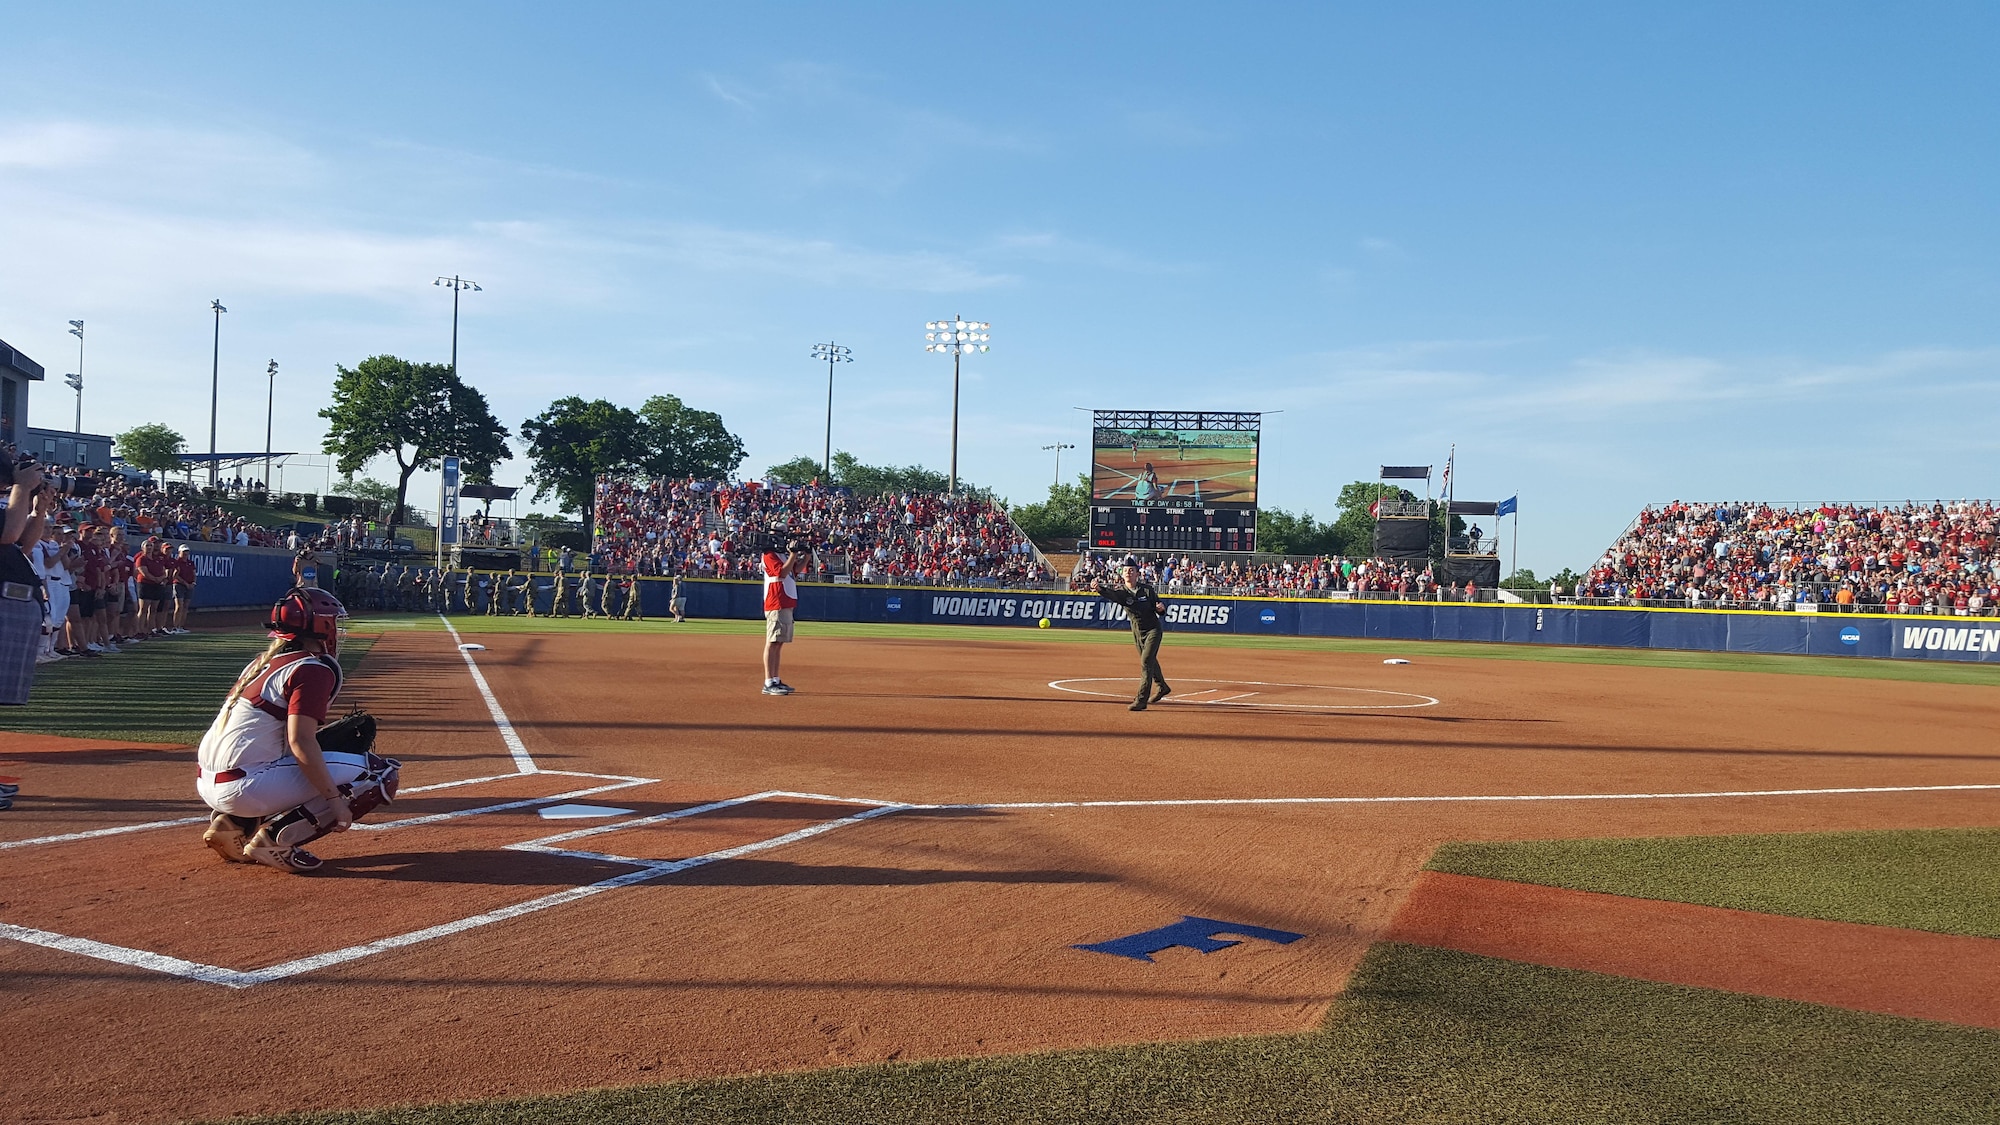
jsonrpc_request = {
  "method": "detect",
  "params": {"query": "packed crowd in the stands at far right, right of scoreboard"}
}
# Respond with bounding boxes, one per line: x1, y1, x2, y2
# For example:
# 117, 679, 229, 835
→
1574, 500, 2000, 615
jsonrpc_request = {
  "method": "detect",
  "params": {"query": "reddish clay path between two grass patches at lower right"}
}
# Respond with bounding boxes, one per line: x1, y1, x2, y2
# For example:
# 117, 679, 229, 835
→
1388, 871, 2000, 1029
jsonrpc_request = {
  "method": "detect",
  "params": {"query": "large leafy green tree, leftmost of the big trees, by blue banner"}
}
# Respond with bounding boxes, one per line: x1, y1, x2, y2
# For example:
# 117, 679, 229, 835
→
320, 356, 514, 538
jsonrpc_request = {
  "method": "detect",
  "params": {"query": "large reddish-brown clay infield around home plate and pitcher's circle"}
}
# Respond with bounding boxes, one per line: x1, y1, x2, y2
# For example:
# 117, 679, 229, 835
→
0, 625, 2000, 1121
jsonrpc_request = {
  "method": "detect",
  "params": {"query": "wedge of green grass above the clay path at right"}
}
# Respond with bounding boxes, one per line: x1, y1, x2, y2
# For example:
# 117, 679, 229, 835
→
1430, 829, 2000, 937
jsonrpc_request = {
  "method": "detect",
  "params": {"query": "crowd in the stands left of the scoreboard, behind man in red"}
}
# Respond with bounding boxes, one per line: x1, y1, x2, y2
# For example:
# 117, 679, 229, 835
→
596, 480, 1054, 587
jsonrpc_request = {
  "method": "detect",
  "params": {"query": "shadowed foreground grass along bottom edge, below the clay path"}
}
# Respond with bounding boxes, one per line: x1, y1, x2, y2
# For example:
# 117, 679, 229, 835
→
223, 945, 2000, 1125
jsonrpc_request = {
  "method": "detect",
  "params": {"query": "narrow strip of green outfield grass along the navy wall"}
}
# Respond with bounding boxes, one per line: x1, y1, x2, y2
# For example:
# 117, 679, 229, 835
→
358, 615, 2000, 685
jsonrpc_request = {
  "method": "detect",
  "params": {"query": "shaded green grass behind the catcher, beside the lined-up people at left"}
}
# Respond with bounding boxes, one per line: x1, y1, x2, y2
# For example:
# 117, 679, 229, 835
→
0, 631, 374, 743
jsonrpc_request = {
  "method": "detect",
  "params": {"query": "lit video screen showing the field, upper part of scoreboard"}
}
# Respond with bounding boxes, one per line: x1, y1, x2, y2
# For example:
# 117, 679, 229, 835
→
1090, 420, 1258, 508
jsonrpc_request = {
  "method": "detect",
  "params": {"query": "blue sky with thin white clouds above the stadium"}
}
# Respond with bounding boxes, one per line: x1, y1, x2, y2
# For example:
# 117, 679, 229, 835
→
0, 2, 2000, 573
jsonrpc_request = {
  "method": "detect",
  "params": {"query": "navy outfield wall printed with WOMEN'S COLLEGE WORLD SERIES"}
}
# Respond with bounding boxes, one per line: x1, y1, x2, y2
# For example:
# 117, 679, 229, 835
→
664, 581, 2000, 663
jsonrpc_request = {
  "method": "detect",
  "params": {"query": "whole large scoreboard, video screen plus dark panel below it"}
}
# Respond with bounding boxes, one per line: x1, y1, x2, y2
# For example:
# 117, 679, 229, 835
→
1090, 410, 1262, 552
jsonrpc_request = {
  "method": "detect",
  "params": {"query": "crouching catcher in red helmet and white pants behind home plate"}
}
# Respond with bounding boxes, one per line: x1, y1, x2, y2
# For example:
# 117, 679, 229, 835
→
196, 587, 402, 871
